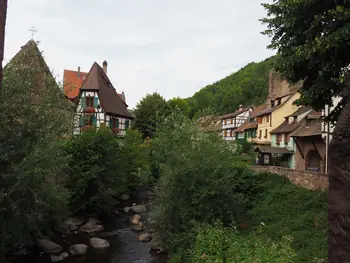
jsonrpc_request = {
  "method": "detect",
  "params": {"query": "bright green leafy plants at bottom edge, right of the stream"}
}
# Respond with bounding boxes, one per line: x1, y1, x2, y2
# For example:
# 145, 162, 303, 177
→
188, 223, 295, 263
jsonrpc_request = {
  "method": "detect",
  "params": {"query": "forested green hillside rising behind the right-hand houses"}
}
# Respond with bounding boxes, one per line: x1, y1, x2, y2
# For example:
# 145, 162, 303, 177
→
186, 57, 273, 117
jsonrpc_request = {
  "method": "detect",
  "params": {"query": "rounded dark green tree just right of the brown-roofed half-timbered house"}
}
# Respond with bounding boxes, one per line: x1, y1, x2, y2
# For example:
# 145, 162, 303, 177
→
133, 93, 170, 138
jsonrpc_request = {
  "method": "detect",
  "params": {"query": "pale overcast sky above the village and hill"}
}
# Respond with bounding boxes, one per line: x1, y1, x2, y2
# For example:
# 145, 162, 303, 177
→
4, 0, 275, 108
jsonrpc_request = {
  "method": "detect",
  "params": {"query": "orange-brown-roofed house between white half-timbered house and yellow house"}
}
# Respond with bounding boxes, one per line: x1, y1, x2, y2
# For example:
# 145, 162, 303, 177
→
235, 104, 267, 143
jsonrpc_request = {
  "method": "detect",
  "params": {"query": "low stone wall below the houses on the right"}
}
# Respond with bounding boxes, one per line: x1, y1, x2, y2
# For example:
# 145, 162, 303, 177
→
251, 166, 328, 190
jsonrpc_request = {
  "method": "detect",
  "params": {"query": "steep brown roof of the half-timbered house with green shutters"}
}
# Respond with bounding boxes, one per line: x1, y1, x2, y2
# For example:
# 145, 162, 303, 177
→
80, 62, 134, 119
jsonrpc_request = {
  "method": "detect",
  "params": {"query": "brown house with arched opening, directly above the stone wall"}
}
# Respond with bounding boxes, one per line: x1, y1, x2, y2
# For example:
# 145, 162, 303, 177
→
290, 111, 326, 173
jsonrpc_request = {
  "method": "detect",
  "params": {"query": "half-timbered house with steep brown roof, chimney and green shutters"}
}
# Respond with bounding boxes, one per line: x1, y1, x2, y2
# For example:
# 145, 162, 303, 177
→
73, 61, 134, 136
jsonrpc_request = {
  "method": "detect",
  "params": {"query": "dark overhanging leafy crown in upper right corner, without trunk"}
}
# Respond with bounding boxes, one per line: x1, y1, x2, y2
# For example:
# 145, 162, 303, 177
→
262, 0, 350, 124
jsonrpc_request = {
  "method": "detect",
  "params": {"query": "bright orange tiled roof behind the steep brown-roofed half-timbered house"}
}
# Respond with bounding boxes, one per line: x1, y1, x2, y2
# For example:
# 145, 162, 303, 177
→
63, 69, 88, 99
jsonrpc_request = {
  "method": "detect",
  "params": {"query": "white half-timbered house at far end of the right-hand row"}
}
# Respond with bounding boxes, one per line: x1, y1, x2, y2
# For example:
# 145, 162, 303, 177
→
220, 105, 253, 141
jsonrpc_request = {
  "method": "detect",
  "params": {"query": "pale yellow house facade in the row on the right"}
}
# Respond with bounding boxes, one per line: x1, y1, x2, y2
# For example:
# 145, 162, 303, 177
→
256, 91, 300, 145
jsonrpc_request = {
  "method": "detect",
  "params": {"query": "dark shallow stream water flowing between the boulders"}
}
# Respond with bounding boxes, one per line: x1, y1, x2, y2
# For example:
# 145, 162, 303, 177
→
12, 191, 167, 263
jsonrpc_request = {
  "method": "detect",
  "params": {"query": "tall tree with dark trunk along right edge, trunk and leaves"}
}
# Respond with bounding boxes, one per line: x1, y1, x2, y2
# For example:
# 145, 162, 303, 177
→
262, 0, 350, 263
